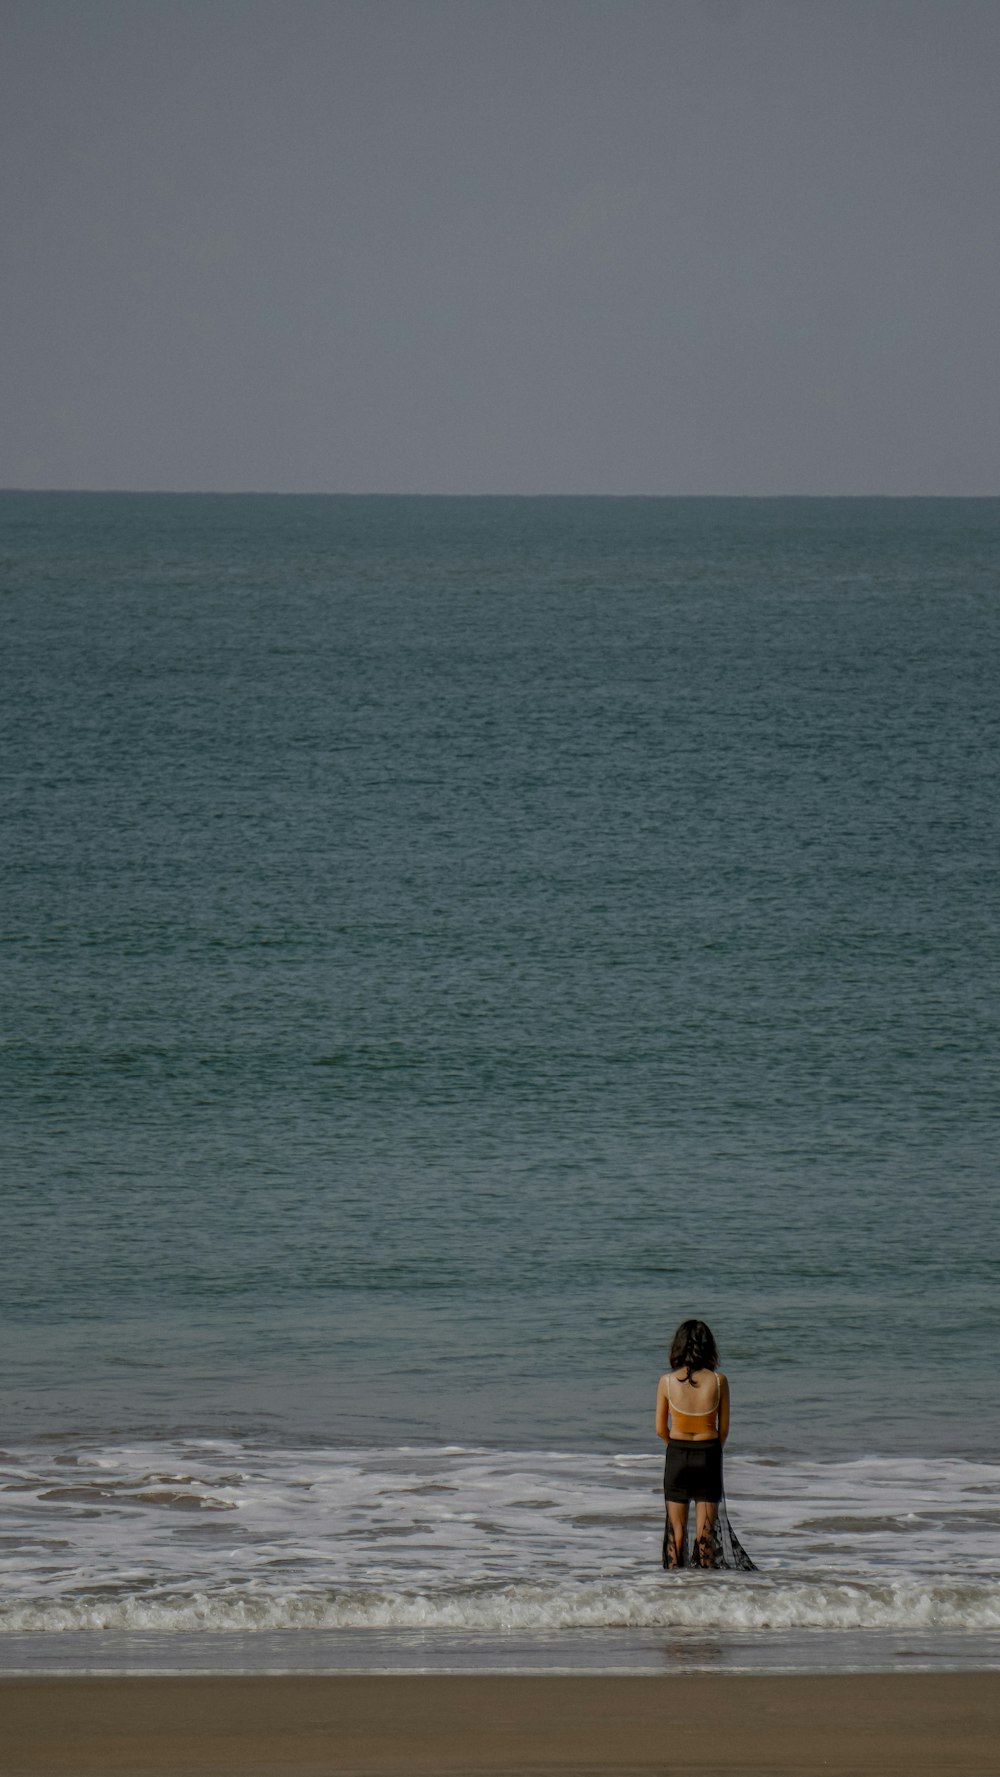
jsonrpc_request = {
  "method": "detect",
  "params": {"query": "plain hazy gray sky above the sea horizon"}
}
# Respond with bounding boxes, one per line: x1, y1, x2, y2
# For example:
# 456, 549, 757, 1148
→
0, 0, 1000, 494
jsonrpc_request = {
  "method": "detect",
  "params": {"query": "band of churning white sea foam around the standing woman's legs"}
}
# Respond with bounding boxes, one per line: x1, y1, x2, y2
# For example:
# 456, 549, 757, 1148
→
0, 1439, 1000, 1633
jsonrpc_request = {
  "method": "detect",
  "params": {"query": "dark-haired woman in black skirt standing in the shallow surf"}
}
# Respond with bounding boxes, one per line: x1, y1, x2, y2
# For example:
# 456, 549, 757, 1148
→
655, 1320, 753, 1571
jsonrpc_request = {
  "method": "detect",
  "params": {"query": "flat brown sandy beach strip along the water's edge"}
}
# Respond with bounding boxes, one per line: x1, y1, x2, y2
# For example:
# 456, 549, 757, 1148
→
0, 1672, 1000, 1777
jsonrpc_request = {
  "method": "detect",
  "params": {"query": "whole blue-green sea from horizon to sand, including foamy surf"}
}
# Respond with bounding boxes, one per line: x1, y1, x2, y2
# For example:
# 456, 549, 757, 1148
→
0, 492, 1000, 1670
